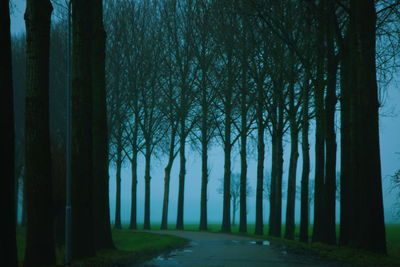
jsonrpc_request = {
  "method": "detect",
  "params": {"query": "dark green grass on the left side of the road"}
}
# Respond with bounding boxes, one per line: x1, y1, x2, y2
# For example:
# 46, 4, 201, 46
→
17, 228, 188, 266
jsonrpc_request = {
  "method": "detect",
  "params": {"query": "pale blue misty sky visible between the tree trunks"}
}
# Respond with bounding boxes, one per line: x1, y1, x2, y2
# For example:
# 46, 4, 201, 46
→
11, 0, 400, 227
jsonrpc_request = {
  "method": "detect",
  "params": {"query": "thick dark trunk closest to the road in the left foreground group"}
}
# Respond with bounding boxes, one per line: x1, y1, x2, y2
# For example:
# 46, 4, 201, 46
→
92, 0, 114, 249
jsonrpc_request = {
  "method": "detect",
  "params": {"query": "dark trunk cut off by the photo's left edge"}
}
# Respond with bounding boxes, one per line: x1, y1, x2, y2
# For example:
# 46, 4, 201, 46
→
0, 0, 17, 267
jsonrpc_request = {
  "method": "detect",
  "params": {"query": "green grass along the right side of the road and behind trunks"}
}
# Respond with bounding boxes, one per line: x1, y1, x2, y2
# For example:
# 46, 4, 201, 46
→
129, 224, 400, 266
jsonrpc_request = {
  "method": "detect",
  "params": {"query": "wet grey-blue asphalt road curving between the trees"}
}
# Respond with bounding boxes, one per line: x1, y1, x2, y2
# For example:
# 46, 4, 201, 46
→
140, 230, 341, 267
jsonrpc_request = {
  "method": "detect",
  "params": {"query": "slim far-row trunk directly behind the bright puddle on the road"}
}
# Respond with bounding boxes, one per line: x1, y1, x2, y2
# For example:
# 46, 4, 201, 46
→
254, 85, 265, 235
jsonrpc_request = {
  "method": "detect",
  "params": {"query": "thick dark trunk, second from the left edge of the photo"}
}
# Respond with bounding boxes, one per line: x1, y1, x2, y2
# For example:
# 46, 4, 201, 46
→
24, 0, 55, 266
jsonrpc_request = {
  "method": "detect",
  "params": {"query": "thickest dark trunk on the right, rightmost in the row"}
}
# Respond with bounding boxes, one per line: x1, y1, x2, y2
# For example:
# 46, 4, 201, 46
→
346, 0, 386, 253
